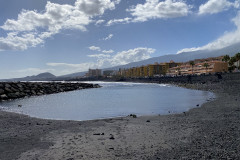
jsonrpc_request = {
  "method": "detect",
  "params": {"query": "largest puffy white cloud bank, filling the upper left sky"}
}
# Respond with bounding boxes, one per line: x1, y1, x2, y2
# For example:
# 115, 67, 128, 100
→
0, 0, 120, 51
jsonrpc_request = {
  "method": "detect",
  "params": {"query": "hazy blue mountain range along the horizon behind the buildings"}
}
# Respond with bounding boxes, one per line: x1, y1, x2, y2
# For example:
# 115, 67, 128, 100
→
0, 43, 240, 81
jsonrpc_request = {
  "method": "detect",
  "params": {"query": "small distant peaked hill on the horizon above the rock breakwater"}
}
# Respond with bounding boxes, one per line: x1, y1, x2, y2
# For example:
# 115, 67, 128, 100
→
0, 72, 56, 81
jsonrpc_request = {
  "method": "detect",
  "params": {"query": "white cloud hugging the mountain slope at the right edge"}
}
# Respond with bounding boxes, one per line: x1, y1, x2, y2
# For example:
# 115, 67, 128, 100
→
177, 11, 240, 54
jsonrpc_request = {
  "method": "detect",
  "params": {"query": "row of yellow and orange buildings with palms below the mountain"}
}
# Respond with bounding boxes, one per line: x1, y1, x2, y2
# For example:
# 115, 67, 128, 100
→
85, 53, 240, 78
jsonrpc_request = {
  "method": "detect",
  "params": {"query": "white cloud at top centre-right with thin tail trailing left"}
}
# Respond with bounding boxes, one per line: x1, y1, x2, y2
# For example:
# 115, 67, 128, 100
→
107, 0, 192, 26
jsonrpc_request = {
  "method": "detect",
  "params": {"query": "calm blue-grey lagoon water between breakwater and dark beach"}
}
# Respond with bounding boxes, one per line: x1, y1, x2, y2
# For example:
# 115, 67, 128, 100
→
0, 82, 214, 120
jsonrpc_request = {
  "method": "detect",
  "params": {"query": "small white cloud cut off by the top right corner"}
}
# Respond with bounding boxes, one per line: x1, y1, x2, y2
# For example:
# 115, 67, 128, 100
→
198, 0, 239, 15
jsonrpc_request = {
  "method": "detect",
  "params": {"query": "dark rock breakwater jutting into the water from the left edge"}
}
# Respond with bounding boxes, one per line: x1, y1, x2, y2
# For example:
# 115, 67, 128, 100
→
0, 82, 100, 102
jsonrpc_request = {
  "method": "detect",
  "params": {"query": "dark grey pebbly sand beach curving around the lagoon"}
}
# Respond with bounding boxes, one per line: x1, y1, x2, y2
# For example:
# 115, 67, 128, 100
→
0, 74, 240, 160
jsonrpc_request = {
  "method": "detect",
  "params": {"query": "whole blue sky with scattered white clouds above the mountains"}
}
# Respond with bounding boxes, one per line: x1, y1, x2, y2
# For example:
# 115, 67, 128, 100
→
0, 0, 240, 79
